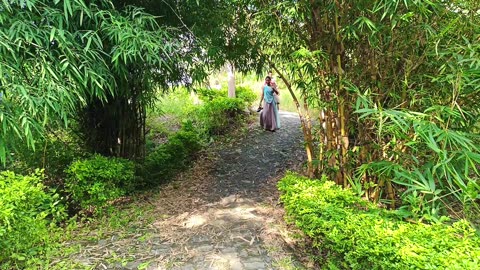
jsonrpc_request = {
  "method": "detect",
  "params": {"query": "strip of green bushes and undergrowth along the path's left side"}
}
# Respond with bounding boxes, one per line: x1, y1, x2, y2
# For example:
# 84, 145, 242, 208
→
0, 85, 255, 269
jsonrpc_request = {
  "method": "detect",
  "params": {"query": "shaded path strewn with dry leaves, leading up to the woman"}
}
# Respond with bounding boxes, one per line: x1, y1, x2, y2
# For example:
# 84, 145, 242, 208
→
66, 112, 304, 270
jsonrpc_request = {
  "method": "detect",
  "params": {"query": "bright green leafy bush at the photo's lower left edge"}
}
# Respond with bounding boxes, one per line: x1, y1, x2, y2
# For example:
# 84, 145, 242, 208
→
0, 170, 65, 268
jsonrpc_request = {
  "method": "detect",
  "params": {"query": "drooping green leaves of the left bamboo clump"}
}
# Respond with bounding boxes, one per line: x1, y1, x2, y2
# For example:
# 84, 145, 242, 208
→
0, 0, 179, 161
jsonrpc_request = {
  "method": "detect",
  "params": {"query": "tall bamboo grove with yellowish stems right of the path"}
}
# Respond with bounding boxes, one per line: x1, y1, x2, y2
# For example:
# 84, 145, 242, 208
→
251, 0, 480, 219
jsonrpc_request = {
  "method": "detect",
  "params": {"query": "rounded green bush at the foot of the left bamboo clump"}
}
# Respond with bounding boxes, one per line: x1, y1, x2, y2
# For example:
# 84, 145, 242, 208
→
65, 155, 135, 209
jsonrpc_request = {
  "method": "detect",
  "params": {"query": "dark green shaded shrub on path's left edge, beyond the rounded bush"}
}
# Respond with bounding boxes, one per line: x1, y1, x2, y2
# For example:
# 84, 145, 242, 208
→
140, 122, 202, 186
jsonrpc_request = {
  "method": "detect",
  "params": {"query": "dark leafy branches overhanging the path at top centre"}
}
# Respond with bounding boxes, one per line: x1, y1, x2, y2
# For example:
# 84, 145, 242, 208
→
113, 0, 263, 78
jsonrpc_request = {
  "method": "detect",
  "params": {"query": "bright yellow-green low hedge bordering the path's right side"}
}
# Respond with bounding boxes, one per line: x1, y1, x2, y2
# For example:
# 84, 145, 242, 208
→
279, 174, 480, 269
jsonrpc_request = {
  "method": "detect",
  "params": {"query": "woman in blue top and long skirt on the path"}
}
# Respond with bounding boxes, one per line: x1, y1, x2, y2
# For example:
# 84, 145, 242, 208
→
260, 76, 280, 132
